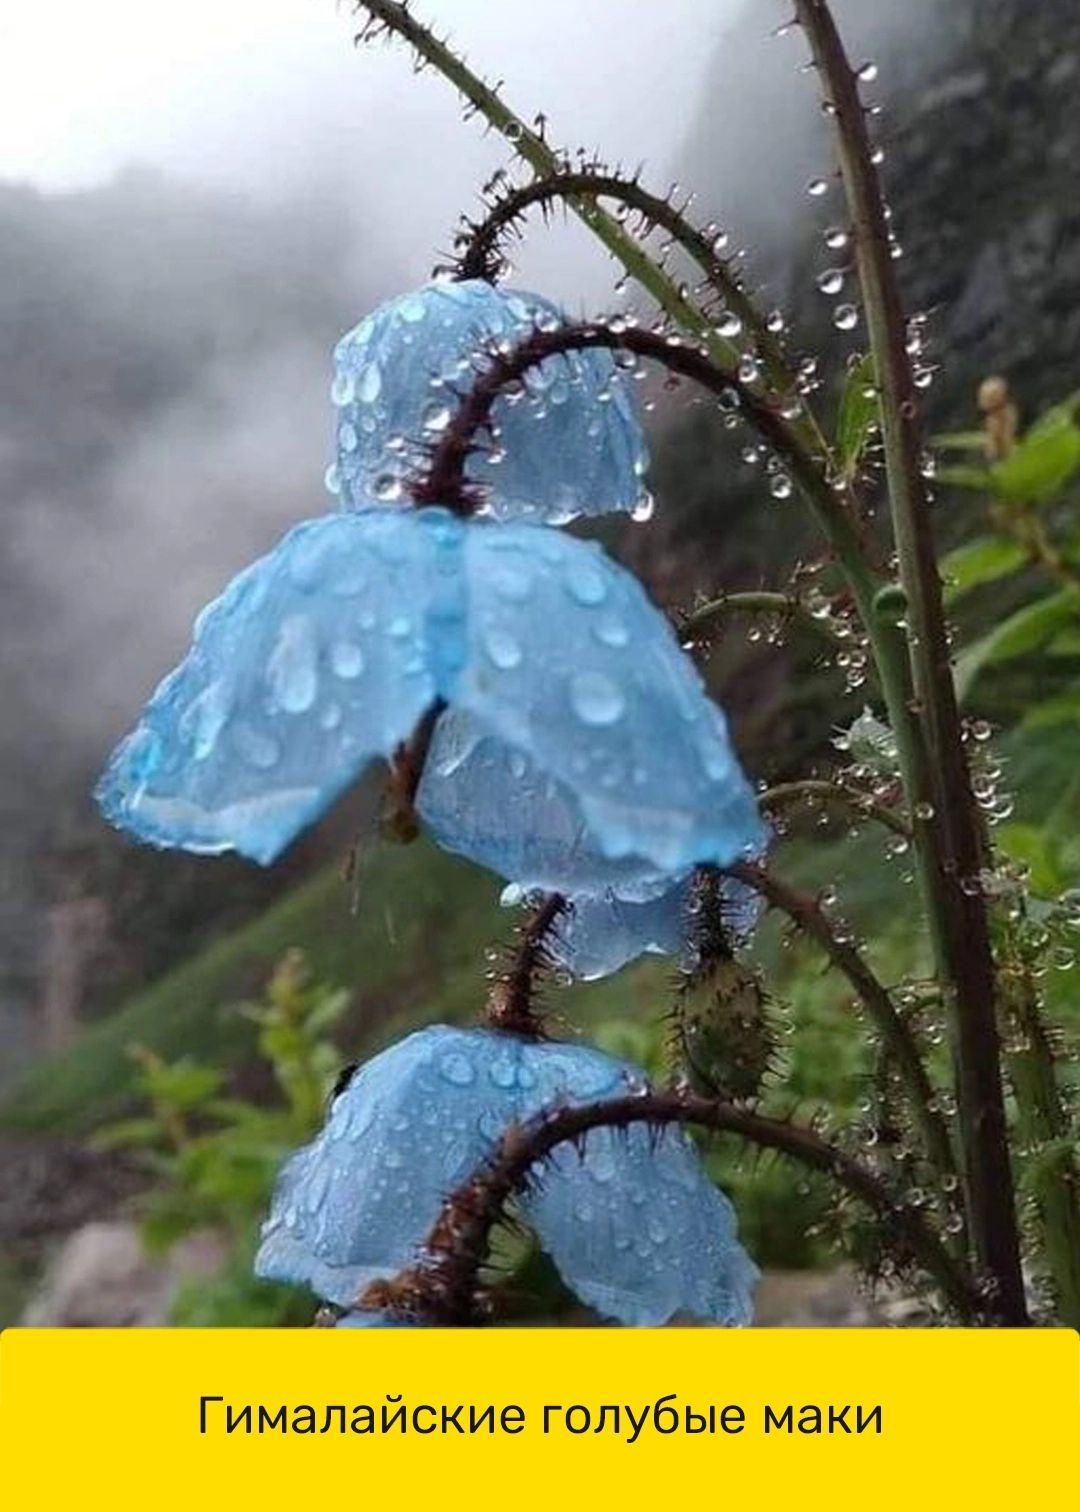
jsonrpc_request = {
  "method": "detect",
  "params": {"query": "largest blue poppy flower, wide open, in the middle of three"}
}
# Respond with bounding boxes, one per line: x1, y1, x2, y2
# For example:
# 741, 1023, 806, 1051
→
97, 508, 761, 891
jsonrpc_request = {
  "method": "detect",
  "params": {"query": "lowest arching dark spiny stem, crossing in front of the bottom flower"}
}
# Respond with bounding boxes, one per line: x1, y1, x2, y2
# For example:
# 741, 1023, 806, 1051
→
358, 1090, 985, 1325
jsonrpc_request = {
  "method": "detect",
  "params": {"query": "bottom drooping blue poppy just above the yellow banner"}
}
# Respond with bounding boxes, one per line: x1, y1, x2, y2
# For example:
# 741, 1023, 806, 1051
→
256, 1025, 756, 1326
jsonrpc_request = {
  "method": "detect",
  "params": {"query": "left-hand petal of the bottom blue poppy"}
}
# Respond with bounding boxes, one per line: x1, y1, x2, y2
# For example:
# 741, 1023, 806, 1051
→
256, 1025, 520, 1306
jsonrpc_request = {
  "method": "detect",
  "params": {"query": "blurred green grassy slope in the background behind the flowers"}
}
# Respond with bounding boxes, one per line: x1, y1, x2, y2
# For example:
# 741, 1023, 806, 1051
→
0, 842, 663, 1134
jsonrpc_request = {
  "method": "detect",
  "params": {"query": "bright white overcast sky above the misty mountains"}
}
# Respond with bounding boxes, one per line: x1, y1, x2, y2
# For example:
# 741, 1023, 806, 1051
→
0, 0, 741, 300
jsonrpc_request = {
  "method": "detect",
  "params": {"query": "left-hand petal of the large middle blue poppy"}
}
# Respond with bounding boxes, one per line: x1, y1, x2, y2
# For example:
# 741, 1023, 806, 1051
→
97, 510, 463, 862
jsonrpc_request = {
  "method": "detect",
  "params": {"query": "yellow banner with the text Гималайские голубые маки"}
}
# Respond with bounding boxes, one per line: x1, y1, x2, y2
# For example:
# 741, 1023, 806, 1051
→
0, 1329, 1080, 1512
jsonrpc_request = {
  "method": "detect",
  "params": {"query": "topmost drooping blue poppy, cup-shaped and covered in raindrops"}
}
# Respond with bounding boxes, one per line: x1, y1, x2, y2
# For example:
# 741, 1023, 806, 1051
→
328, 280, 649, 525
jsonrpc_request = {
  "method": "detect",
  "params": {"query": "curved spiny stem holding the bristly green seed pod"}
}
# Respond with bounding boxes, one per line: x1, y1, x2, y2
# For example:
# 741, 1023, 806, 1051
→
725, 860, 956, 1178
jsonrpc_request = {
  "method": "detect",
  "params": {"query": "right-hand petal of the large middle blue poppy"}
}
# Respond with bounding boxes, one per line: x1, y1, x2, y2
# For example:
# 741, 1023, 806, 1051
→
422, 523, 764, 892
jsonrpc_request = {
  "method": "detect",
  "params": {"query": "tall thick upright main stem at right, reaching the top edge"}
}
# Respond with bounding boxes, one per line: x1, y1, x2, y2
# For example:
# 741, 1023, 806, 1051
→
796, 0, 1027, 1325
